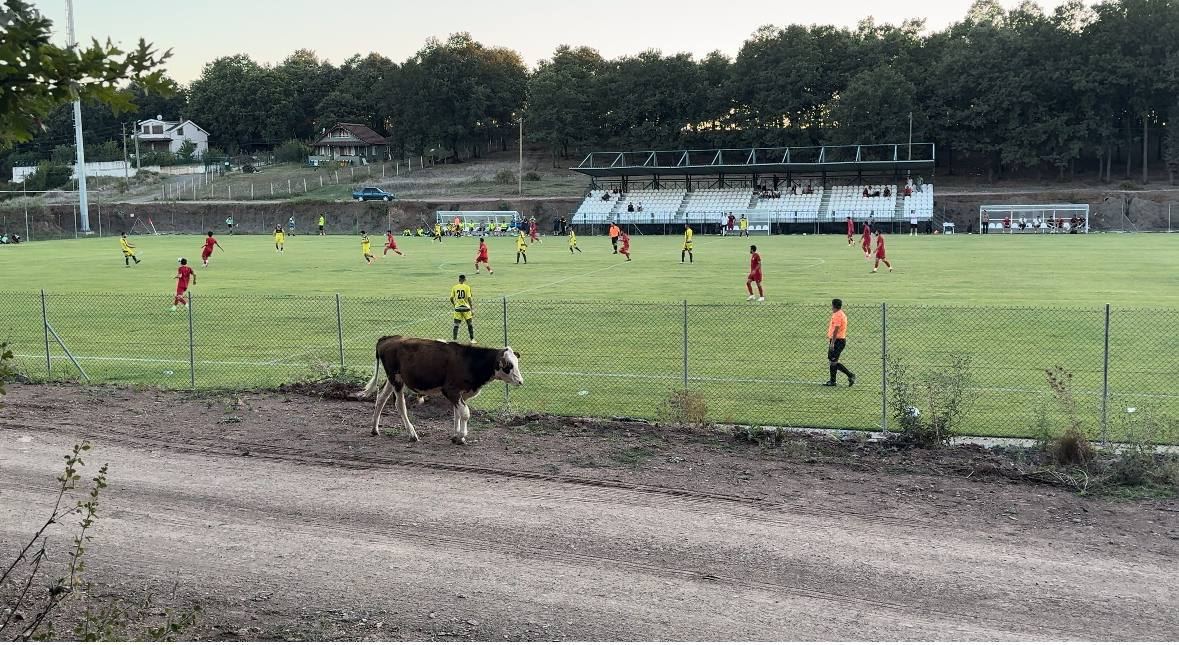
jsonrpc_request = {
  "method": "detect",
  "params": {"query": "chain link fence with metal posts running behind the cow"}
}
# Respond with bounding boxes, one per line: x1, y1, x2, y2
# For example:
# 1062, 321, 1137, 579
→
0, 292, 1179, 436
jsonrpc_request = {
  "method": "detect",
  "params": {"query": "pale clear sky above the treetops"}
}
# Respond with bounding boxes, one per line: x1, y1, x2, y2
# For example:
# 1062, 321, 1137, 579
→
32, 0, 1062, 84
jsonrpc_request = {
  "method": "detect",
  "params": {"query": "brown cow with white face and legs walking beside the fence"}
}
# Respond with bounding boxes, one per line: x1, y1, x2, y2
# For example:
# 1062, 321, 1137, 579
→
357, 336, 523, 443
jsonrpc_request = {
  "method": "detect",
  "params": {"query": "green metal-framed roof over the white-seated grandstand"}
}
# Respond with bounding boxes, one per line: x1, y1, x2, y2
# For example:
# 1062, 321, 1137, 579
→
569, 143, 936, 177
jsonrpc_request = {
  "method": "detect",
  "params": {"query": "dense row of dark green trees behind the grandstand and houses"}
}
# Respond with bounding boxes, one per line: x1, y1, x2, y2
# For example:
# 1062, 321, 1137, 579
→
6, 0, 1179, 180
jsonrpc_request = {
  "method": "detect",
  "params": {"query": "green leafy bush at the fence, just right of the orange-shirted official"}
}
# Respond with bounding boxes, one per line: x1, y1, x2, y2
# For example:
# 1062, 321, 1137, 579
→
888, 356, 975, 448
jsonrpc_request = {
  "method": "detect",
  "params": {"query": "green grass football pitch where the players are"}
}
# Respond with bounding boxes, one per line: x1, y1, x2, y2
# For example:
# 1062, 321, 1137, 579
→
0, 228, 1179, 435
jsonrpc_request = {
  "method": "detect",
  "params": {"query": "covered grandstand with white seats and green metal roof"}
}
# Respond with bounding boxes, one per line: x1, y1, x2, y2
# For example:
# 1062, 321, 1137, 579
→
572, 144, 934, 233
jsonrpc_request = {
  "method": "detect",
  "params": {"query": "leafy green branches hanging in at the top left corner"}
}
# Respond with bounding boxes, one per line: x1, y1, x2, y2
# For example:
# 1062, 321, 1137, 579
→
0, 0, 171, 150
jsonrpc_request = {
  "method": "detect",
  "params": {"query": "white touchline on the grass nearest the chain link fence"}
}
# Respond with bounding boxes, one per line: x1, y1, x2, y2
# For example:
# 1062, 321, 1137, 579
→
15, 354, 1179, 399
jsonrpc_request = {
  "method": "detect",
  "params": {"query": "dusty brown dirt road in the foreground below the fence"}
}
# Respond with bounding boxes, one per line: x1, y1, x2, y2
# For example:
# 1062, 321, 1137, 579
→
0, 386, 1179, 640
